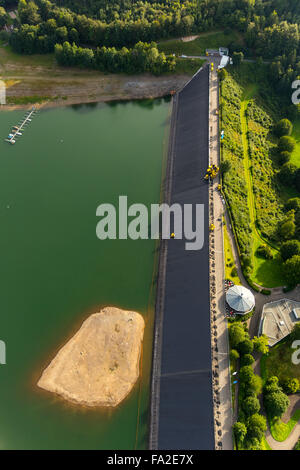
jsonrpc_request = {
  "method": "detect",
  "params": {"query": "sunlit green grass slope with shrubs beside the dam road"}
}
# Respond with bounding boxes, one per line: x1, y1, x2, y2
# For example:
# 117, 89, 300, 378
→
221, 64, 286, 288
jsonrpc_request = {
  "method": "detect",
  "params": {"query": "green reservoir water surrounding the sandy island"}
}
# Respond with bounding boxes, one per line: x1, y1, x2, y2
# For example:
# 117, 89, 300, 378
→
0, 97, 169, 449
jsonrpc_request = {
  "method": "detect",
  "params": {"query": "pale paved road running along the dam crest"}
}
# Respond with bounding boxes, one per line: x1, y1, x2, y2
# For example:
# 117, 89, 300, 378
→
209, 60, 233, 450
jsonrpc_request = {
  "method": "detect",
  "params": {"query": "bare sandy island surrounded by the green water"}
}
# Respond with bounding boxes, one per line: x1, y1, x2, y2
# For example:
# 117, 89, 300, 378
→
37, 307, 145, 406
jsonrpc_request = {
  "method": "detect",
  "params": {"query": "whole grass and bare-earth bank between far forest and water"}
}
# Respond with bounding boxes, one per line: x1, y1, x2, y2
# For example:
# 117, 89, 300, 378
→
0, 51, 190, 109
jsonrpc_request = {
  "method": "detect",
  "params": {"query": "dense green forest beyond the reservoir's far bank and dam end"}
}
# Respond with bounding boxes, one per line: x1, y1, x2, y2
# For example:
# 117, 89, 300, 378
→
0, 0, 300, 79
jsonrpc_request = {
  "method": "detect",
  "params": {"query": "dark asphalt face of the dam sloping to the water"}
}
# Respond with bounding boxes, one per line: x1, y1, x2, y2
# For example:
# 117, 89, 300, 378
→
149, 66, 215, 450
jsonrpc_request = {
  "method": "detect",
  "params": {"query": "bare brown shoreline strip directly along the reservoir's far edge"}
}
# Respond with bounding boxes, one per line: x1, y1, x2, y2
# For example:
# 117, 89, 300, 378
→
0, 74, 191, 112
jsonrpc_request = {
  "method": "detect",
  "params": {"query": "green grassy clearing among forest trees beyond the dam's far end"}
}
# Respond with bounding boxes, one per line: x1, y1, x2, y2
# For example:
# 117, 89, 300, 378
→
158, 31, 243, 55
